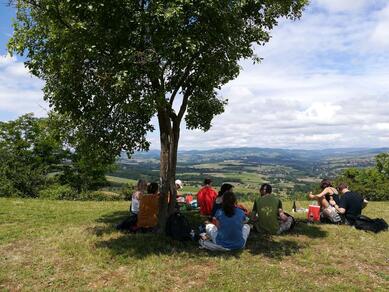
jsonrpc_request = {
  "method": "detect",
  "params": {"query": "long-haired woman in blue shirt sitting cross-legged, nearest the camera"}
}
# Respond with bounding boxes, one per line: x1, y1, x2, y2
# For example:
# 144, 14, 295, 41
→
205, 192, 250, 250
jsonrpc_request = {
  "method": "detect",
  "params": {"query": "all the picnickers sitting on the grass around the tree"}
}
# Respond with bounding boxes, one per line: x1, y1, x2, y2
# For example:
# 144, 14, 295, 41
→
121, 179, 367, 250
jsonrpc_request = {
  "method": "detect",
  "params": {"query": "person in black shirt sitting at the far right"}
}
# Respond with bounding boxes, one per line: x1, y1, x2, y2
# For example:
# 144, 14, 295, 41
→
331, 183, 367, 225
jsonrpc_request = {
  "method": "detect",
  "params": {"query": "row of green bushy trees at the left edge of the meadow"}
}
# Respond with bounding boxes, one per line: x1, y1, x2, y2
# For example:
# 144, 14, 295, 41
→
0, 113, 114, 198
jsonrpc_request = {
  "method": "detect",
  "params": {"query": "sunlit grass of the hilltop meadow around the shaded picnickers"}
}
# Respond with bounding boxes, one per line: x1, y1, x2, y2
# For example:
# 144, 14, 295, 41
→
0, 198, 389, 291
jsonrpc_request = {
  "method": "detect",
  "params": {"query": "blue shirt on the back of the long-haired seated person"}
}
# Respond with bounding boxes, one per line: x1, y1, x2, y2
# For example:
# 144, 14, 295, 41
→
215, 208, 246, 249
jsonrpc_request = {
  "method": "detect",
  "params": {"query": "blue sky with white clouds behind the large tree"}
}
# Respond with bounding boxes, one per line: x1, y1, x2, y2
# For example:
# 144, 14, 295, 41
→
0, 0, 389, 150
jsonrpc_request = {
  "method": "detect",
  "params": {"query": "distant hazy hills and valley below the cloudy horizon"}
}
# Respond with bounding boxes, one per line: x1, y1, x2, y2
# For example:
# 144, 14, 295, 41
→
118, 148, 389, 180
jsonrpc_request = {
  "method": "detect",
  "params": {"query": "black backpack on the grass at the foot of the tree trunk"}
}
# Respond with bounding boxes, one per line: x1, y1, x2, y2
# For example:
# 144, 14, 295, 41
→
166, 212, 192, 241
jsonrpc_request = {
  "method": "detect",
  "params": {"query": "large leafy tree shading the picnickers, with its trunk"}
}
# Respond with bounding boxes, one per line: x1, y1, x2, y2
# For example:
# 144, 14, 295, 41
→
9, 0, 307, 228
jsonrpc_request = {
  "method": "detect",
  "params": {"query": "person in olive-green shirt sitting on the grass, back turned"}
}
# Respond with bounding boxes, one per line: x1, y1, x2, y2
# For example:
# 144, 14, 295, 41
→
251, 184, 293, 234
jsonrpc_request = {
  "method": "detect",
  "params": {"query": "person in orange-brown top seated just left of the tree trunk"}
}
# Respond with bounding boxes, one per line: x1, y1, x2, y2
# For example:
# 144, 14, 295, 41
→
137, 182, 159, 228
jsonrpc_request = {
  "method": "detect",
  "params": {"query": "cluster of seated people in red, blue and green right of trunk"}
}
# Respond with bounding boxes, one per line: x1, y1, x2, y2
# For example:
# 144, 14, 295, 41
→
197, 179, 294, 250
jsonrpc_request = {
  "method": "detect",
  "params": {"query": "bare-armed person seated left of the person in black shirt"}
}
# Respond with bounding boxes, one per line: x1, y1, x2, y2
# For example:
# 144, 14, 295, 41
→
308, 179, 341, 223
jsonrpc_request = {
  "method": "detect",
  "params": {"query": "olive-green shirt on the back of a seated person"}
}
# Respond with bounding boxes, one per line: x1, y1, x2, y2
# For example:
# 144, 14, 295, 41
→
254, 194, 282, 234
